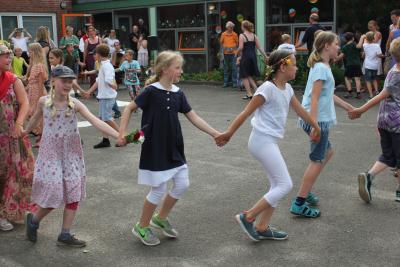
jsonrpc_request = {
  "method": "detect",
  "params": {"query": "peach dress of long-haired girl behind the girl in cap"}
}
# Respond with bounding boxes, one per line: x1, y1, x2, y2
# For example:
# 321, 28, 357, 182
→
26, 64, 47, 135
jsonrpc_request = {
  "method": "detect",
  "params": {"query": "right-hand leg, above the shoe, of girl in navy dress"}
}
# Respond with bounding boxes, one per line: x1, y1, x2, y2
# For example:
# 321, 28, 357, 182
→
158, 172, 190, 219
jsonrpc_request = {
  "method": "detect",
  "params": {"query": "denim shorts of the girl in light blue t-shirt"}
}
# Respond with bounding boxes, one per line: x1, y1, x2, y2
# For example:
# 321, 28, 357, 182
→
302, 124, 332, 163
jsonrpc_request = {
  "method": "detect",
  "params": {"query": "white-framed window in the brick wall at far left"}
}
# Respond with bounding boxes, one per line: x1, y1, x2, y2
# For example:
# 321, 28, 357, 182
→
0, 13, 57, 44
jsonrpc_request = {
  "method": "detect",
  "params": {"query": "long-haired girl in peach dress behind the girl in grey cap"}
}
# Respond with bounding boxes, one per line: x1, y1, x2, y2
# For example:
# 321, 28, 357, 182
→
26, 43, 48, 147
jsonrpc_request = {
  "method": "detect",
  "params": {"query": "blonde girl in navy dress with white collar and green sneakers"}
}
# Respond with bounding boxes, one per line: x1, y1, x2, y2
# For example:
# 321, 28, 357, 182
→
118, 51, 219, 246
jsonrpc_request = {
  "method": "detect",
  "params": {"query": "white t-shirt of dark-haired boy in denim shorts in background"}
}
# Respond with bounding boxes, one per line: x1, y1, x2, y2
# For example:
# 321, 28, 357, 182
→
96, 60, 117, 99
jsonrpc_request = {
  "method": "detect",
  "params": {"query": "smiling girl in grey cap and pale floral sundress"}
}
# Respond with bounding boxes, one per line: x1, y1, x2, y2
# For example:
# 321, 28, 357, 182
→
26, 66, 118, 247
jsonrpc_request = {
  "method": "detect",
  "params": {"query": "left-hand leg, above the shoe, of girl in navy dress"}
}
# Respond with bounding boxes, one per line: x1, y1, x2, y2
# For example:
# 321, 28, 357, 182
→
139, 183, 167, 228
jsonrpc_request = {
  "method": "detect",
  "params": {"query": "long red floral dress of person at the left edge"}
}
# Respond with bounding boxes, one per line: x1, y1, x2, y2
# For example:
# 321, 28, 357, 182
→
0, 75, 36, 222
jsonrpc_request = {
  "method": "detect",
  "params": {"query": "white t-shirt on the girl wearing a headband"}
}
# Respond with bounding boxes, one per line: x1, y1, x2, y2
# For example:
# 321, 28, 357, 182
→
251, 81, 294, 138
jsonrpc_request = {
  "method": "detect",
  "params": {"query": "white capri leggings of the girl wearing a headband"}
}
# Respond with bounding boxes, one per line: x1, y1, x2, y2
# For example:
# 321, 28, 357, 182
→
248, 131, 293, 208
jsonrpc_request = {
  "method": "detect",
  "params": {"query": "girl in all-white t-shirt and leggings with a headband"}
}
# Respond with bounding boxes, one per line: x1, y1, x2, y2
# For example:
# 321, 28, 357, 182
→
216, 50, 320, 241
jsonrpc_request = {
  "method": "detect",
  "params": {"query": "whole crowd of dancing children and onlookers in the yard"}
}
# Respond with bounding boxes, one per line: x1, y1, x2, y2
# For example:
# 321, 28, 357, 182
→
0, 8, 400, 251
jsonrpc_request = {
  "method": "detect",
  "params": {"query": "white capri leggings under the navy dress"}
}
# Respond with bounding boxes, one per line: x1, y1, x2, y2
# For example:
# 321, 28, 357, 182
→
146, 169, 190, 205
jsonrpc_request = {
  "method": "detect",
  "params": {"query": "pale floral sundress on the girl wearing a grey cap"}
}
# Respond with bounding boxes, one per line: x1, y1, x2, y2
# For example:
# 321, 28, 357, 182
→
32, 96, 86, 208
